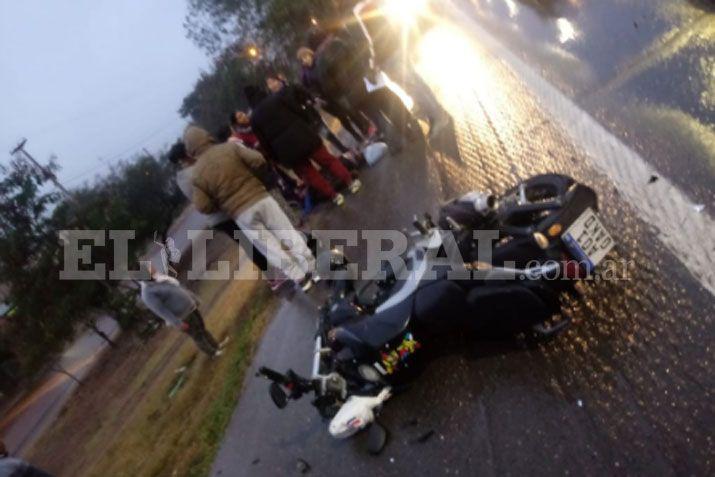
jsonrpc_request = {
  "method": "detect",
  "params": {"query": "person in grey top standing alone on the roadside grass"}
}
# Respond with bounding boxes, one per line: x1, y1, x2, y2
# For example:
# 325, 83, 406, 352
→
139, 268, 223, 357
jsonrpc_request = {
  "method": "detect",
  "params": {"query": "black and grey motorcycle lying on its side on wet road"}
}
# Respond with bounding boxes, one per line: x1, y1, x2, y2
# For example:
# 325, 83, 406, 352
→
259, 174, 614, 438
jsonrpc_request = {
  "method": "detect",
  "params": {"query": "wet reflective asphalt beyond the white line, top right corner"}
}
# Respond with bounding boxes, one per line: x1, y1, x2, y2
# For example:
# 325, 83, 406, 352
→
464, 0, 715, 208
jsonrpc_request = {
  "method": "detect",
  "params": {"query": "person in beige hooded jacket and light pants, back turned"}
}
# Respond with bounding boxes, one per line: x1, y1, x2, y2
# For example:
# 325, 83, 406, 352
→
184, 126, 315, 291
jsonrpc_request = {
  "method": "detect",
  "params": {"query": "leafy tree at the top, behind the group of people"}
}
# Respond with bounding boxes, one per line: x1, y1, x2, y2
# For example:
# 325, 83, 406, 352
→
179, 0, 351, 132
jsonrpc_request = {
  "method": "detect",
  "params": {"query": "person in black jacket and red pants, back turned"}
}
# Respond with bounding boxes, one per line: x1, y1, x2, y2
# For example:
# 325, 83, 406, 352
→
251, 74, 362, 205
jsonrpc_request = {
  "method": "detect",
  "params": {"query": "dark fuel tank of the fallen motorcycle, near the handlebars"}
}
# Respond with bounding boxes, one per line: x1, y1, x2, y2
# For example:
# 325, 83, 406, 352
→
343, 292, 413, 349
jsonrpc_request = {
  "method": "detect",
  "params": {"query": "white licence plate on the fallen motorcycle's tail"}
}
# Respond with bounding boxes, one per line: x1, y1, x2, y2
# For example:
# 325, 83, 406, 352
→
561, 207, 615, 273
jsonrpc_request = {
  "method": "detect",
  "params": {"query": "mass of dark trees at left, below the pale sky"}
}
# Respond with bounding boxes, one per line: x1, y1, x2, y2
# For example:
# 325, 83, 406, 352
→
0, 150, 185, 390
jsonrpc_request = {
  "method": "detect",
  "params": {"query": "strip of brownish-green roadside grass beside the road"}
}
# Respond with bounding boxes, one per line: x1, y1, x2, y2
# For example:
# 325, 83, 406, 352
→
29, 268, 275, 477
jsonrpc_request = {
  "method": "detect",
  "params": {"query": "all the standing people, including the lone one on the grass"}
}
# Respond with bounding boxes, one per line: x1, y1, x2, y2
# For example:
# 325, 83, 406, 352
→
142, 0, 450, 356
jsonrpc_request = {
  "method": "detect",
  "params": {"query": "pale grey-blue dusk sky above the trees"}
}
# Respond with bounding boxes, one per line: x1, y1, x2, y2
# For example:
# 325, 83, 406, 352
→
0, 0, 209, 187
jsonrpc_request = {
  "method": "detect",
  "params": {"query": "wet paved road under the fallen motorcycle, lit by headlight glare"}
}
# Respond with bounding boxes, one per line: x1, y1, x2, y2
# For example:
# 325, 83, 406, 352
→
212, 4, 715, 476
